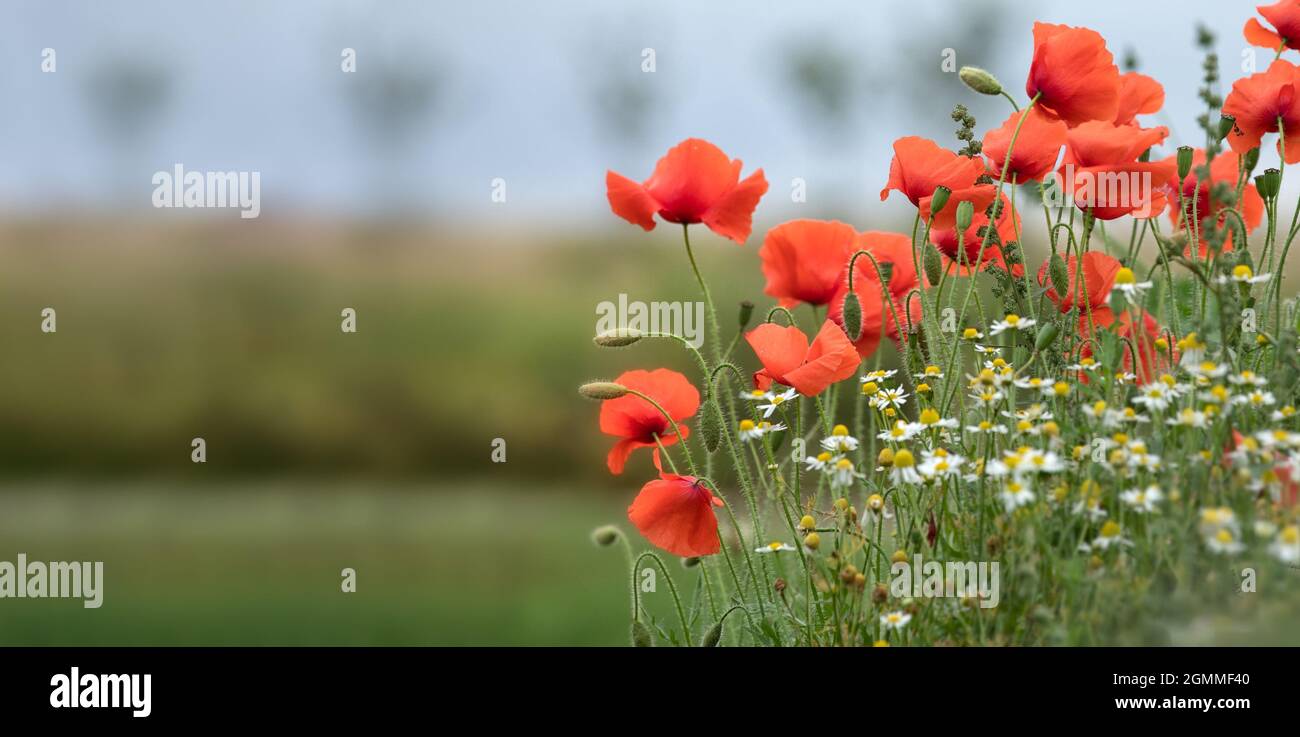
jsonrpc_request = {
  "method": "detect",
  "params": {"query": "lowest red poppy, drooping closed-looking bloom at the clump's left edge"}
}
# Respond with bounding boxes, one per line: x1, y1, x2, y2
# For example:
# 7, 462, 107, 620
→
628, 471, 724, 558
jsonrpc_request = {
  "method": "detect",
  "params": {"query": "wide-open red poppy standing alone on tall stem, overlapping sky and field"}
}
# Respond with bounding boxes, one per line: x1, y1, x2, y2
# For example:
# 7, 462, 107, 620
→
605, 138, 767, 243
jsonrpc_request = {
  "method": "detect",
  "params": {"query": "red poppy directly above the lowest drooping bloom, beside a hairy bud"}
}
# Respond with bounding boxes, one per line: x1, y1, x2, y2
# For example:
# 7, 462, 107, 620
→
601, 369, 699, 474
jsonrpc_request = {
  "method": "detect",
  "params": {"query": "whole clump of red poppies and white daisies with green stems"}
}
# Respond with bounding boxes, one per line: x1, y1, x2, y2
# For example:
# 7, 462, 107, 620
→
581, 10, 1300, 646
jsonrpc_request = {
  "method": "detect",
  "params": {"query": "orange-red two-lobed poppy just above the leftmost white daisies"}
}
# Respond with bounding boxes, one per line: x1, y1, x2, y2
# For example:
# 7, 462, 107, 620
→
745, 320, 862, 396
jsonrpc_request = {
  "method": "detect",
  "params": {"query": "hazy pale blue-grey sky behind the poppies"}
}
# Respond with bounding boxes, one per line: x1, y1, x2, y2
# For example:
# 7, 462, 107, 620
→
0, 0, 1268, 225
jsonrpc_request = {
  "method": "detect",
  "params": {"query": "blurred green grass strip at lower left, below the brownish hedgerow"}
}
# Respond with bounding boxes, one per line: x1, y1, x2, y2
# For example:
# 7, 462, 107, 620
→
0, 482, 655, 645
